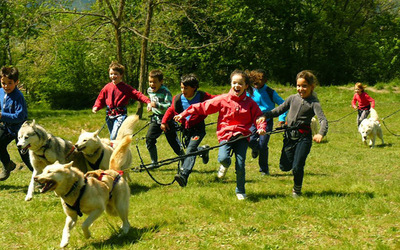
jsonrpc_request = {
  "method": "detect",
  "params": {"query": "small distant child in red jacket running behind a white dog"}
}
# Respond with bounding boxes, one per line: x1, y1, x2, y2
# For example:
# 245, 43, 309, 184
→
351, 82, 375, 127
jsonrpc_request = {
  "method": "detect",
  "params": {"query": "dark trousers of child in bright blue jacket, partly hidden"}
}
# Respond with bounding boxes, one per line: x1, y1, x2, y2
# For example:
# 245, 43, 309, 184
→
249, 119, 274, 173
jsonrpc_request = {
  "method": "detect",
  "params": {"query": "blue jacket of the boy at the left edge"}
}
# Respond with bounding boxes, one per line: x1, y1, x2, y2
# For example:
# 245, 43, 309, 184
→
0, 88, 28, 136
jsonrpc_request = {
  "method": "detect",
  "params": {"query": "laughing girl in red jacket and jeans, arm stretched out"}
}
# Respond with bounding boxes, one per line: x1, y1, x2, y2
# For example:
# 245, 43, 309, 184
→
174, 70, 266, 200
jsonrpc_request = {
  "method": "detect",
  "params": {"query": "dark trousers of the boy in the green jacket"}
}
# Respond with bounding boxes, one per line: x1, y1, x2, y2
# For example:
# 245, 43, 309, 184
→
146, 121, 183, 163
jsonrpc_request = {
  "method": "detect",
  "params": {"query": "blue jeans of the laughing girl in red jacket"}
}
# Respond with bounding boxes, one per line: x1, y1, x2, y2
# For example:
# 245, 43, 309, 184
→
218, 138, 249, 194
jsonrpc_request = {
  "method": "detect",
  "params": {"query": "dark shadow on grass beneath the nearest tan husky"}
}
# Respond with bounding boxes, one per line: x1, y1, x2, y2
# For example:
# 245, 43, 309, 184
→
80, 225, 160, 249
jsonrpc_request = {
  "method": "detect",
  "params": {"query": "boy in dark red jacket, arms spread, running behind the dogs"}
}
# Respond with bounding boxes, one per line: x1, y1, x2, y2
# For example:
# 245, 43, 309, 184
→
92, 62, 150, 140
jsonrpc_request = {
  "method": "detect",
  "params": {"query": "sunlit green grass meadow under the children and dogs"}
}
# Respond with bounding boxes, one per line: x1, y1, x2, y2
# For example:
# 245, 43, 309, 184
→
0, 85, 400, 249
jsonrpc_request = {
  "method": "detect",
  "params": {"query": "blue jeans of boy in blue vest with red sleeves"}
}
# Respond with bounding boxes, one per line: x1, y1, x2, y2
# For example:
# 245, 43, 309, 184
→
180, 131, 206, 179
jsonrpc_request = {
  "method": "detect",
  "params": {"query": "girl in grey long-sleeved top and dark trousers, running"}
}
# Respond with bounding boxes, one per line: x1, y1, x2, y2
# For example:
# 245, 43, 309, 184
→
257, 70, 328, 197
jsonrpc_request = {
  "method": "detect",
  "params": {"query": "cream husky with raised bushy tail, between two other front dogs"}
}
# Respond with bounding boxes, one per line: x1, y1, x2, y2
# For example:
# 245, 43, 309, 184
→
75, 115, 139, 170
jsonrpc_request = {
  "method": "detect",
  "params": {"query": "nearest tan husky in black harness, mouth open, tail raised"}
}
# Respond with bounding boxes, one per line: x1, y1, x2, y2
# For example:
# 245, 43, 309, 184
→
35, 136, 132, 247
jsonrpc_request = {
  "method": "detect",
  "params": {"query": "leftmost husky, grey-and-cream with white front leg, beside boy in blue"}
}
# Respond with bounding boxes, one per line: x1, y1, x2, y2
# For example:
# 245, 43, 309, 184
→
17, 120, 87, 201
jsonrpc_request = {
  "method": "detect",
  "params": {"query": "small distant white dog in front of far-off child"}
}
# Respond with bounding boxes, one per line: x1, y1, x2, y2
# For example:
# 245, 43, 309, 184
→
358, 108, 384, 148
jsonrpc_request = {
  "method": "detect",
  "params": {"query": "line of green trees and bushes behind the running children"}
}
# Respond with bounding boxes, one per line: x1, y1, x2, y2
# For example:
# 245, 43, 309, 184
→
0, 0, 400, 109
